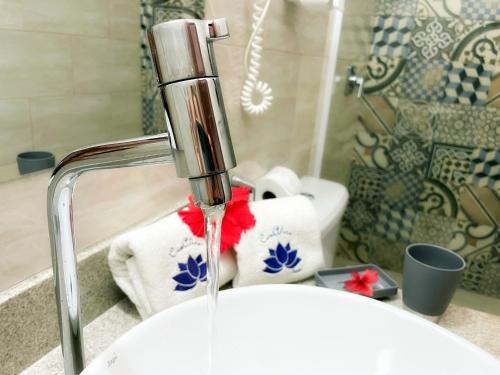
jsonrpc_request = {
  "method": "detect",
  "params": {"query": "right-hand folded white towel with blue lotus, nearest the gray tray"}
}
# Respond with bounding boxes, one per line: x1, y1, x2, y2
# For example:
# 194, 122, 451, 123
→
233, 196, 325, 287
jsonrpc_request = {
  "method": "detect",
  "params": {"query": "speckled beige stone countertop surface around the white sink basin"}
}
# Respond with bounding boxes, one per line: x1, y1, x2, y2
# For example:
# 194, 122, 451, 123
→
21, 288, 500, 375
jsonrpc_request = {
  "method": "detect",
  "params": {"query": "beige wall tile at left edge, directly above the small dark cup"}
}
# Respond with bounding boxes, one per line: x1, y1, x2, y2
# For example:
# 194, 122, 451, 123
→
0, 99, 32, 165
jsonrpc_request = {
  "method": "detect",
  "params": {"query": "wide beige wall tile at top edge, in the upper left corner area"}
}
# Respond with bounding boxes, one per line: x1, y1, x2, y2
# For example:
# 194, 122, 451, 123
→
18, 0, 108, 36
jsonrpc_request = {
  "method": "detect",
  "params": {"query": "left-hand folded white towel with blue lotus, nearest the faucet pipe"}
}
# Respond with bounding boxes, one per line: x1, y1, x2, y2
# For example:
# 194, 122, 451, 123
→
108, 214, 236, 319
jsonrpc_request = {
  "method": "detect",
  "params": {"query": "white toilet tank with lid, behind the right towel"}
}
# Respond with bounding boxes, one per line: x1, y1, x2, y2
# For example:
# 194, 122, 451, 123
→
300, 176, 349, 267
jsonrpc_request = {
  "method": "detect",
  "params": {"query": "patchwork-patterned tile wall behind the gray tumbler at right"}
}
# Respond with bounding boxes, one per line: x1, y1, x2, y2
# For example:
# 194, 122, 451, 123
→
338, 0, 500, 298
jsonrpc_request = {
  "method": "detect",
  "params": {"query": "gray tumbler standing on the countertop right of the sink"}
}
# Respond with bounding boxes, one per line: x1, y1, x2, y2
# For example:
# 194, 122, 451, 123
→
403, 243, 465, 316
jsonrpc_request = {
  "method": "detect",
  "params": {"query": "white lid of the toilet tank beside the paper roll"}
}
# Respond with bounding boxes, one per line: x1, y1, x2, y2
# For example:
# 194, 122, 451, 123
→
301, 176, 349, 233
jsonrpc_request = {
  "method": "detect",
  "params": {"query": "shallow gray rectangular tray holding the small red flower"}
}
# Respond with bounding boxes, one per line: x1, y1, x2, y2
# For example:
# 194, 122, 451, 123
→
314, 264, 398, 298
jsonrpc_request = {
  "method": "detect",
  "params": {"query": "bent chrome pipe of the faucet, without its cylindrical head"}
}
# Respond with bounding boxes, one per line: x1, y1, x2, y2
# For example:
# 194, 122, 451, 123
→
47, 134, 174, 375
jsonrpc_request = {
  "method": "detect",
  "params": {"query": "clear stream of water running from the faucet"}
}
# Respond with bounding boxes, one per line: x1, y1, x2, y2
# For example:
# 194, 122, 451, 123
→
203, 204, 226, 375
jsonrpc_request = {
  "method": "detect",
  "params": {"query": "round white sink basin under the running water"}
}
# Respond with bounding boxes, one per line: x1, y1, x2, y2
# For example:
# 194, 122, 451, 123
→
83, 285, 500, 375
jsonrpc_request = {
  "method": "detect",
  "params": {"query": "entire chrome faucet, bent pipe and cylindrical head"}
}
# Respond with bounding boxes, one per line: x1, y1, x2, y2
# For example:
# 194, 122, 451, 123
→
47, 19, 236, 375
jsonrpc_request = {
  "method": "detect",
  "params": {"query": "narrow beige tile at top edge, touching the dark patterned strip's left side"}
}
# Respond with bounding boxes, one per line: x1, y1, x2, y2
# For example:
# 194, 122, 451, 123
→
108, 0, 141, 43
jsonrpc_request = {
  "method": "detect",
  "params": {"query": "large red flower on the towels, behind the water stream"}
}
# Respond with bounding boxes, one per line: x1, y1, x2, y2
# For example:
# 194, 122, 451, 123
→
178, 187, 255, 253
